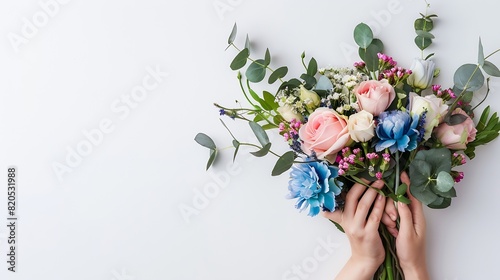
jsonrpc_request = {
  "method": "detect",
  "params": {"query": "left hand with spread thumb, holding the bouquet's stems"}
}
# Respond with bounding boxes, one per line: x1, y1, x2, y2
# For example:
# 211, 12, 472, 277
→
323, 180, 386, 279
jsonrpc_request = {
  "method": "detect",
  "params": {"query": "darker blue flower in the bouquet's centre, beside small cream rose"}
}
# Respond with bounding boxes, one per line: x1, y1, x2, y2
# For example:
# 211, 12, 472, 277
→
375, 110, 419, 153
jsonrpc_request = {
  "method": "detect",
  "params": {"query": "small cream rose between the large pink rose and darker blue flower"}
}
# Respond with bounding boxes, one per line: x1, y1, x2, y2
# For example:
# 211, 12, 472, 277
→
347, 110, 375, 142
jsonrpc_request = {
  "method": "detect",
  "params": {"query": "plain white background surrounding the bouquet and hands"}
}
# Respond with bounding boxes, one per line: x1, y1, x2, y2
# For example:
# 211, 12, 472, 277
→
0, 0, 500, 280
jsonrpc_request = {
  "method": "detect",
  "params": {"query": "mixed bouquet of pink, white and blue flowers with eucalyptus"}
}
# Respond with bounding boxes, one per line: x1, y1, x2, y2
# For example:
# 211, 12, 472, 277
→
195, 3, 500, 279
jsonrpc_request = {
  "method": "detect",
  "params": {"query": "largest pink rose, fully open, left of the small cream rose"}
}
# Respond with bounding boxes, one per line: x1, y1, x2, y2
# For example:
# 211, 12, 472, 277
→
299, 107, 351, 159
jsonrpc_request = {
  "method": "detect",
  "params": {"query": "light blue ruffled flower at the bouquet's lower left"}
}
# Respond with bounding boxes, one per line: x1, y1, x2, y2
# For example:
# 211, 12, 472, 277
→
287, 161, 340, 216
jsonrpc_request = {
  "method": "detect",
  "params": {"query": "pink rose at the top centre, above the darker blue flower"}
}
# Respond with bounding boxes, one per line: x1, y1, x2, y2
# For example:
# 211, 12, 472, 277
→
354, 79, 396, 116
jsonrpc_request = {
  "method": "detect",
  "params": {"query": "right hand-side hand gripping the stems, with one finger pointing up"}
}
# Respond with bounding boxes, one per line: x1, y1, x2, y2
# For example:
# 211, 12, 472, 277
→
382, 172, 429, 280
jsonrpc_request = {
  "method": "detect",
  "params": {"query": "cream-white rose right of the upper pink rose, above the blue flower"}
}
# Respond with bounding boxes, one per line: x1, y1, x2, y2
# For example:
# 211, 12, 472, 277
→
410, 92, 448, 140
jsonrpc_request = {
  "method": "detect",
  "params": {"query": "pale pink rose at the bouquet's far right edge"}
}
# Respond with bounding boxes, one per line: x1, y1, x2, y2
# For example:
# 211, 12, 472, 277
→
434, 108, 477, 150
